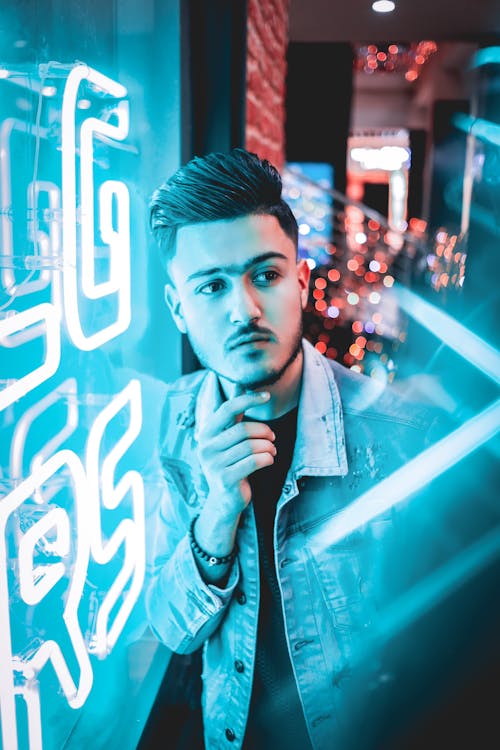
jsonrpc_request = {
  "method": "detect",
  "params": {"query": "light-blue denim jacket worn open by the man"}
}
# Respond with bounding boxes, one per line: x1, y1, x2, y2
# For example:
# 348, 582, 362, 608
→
146, 340, 442, 750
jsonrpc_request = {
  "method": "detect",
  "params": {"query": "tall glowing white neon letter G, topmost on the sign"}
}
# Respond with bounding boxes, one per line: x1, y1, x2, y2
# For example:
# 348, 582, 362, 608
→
62, 65, 131, 351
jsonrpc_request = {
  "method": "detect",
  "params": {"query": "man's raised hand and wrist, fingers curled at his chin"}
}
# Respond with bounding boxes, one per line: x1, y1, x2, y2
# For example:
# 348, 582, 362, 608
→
194, 392, 276, 582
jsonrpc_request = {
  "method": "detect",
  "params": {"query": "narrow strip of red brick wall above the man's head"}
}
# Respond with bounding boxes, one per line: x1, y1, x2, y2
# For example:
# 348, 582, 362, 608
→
245, 0, 290, 169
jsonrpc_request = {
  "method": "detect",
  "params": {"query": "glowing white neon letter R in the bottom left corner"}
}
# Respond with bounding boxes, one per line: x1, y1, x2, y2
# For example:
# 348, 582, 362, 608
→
0, 450, 93, 750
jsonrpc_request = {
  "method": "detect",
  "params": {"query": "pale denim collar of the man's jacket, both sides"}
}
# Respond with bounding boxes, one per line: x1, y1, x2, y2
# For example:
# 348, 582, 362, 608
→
194, 339, 347, 478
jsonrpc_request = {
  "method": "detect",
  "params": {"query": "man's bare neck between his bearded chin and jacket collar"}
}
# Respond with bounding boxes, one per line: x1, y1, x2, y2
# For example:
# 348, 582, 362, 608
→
219, 349, 304, 421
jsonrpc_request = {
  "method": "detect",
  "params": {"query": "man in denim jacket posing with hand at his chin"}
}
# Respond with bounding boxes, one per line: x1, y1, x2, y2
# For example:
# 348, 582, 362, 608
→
147, 149, 446, 750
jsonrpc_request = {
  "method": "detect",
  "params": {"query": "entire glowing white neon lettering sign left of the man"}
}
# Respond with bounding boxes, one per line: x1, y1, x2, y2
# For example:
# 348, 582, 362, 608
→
0, 64, 145, 750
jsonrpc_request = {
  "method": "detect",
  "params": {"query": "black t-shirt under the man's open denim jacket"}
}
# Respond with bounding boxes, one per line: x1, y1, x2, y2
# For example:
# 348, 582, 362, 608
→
243, 408, 311, 750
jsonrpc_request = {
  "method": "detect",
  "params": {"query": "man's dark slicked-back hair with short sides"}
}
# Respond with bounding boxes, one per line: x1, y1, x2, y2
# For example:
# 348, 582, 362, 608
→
149, 148, 298, 262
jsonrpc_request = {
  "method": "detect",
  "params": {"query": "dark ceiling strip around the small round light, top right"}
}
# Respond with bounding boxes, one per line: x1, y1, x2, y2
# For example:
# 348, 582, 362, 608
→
290, 0, 500, 45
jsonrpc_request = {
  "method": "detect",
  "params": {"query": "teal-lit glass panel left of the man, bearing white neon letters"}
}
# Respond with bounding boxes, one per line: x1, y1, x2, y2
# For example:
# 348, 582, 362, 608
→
0, 0, 181, 750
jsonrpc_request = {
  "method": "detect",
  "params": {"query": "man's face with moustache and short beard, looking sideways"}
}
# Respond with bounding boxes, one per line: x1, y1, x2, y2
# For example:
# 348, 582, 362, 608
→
165, 215, 310, 388
